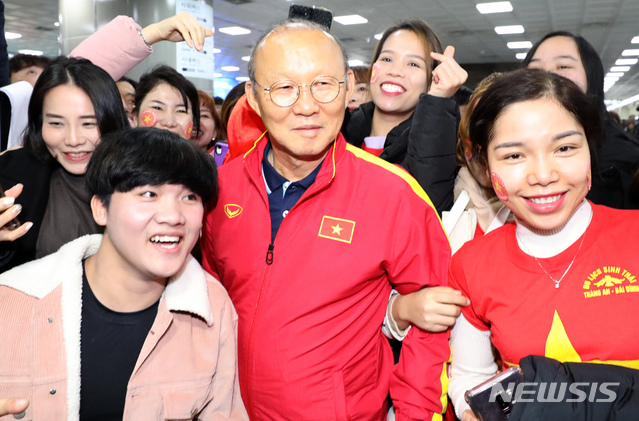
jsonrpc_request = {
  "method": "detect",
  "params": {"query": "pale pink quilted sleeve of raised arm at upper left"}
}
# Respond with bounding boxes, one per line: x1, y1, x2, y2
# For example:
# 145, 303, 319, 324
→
69, 16, 153, 81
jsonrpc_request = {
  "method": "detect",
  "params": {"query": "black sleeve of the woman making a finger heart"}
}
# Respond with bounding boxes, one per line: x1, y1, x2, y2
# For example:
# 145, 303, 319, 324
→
401, 94, 460, 215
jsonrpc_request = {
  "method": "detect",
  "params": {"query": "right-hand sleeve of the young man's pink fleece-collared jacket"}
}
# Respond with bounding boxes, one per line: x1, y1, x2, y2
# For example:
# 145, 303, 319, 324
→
198, 285, 248, 421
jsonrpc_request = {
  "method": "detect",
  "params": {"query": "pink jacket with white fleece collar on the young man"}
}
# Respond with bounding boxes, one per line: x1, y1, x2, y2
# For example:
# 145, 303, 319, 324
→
0, 235, 248, 421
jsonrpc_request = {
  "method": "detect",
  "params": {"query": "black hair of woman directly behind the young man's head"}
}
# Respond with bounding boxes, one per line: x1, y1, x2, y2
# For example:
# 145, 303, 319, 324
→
133, 65, 200, 133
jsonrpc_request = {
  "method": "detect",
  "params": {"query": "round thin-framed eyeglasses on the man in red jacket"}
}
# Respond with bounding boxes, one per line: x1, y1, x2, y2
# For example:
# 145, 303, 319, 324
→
255, 76, 346, 107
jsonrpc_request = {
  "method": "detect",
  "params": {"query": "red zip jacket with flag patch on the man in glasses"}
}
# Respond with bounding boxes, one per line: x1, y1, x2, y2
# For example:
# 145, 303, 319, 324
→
202, 134, 450, 420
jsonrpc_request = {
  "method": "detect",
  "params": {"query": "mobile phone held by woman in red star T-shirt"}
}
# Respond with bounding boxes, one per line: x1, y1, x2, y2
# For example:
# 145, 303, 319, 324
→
464, 367, 524, 421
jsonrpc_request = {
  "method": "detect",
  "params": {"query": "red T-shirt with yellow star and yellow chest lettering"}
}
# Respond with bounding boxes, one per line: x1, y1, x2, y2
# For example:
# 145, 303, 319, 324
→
450, 205, 639, 368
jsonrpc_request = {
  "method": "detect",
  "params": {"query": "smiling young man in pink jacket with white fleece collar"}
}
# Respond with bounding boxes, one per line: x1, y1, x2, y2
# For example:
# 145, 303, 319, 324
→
0, 128, 248, 421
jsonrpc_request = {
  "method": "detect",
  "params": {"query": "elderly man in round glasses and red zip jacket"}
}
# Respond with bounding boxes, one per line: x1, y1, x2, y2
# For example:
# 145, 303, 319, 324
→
202, 21, 450, 420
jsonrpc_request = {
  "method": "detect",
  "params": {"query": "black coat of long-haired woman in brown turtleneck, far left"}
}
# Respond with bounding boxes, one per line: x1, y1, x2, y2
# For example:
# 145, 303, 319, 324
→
0, 148, 53, 272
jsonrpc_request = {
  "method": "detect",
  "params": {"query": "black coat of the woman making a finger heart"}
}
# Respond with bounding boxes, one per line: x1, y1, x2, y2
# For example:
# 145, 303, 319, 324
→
344, 94, 460, 215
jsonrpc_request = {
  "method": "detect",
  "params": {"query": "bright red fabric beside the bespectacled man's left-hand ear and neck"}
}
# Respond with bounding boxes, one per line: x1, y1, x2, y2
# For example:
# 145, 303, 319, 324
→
224, 94, 266, 164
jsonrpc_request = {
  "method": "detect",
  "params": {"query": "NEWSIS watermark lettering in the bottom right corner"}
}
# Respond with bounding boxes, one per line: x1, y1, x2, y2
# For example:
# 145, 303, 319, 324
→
489, 382, 620, 404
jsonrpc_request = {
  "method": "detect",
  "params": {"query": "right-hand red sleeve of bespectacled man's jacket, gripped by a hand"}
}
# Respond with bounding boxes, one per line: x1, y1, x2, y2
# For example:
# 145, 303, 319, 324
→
387, 188, 450, 421
